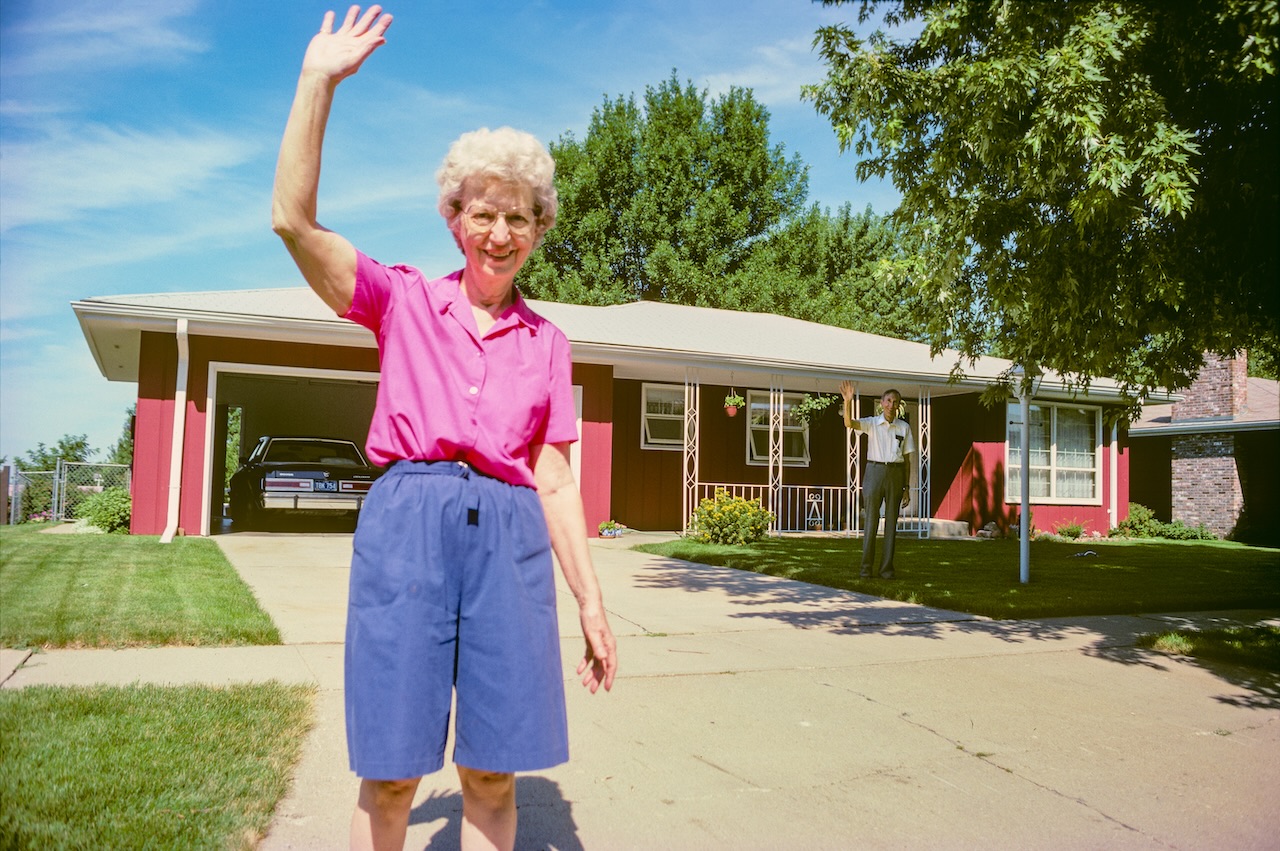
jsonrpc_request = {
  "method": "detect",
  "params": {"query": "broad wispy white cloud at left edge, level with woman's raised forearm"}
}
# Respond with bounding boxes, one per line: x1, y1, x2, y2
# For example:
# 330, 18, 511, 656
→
0, 123, 260, 232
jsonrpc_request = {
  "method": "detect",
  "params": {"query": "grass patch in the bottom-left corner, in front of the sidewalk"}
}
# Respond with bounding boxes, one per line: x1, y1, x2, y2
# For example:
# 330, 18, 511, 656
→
0, 683, 315, 851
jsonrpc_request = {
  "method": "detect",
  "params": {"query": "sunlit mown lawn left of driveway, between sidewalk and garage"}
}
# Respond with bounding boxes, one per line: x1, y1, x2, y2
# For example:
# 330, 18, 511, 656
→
0, 525, 280, 648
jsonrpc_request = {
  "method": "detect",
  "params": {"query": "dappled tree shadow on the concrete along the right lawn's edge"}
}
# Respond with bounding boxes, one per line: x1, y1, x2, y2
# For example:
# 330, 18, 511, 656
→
636, 557, 1280, 709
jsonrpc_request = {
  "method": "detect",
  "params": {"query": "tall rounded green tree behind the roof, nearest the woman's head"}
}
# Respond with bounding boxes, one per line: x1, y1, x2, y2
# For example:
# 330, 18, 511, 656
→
521, 73, 808, 305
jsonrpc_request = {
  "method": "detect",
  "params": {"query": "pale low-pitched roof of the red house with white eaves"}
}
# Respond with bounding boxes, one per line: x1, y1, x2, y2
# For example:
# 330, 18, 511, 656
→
72, 287, 1141, 402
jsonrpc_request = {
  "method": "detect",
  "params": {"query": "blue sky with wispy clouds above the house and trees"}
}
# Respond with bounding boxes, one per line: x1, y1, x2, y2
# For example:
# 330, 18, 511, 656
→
0, 0, 897, 458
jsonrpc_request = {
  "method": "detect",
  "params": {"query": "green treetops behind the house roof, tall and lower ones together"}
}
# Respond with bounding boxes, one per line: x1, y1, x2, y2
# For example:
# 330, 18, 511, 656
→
520, 73, 922, 339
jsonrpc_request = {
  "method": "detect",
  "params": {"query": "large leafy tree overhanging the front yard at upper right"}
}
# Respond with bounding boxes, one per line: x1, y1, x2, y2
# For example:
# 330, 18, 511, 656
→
804, 0, 1280, 397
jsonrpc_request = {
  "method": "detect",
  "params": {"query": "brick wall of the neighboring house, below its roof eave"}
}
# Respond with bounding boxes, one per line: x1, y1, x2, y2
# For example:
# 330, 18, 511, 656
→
1172, 433, 1244, 536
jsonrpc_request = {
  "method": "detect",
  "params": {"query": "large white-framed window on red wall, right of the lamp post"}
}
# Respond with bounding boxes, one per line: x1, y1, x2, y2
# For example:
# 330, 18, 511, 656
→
1005, 402, 1102, 505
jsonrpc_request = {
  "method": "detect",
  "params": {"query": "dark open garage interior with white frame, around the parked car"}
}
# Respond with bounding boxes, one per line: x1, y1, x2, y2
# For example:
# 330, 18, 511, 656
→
206, 363, 378, 535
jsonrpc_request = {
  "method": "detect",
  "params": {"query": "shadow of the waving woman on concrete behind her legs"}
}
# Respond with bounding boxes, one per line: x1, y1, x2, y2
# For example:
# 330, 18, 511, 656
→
408, 775, 582, 851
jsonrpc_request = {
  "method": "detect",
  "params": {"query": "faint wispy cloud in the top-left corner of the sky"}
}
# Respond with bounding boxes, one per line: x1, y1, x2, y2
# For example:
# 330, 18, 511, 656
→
0, 0, 209, 77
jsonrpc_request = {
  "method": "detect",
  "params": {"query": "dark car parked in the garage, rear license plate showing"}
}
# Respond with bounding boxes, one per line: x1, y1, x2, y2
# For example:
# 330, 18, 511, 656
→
229, 435, 383, 529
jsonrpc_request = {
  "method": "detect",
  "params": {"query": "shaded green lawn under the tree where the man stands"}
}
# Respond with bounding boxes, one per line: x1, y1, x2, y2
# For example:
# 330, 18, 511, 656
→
636, 537, 1280, 618
